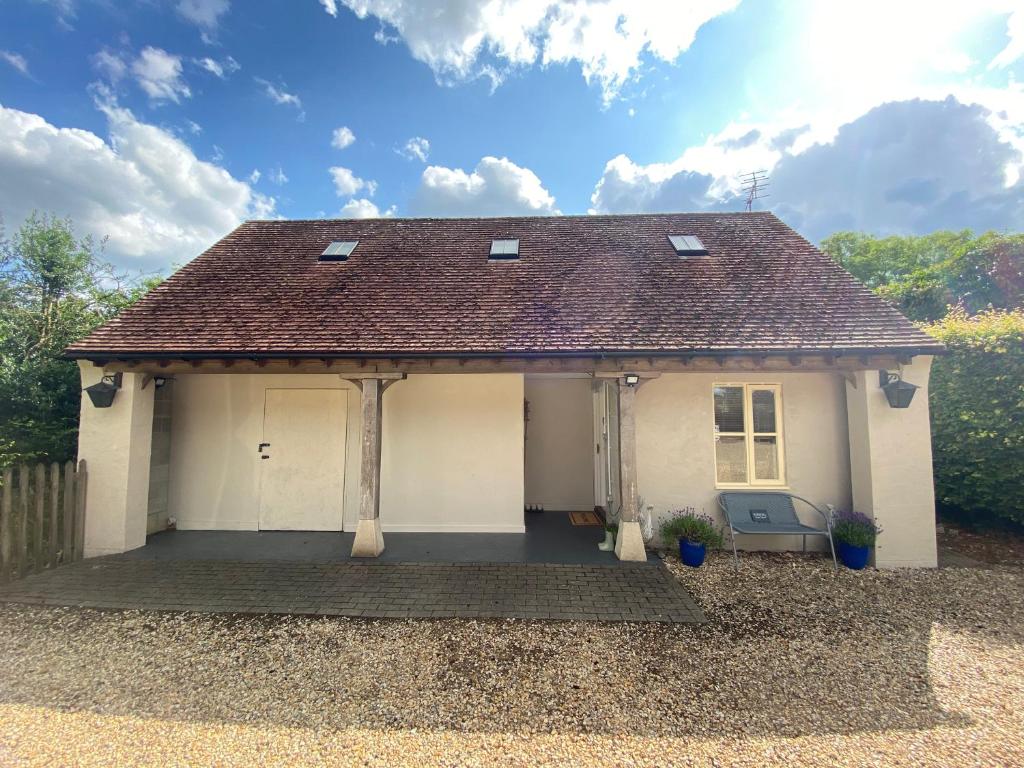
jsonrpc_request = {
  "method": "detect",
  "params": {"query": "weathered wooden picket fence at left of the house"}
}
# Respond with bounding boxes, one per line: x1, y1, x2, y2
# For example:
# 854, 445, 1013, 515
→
0, 461, 87, 582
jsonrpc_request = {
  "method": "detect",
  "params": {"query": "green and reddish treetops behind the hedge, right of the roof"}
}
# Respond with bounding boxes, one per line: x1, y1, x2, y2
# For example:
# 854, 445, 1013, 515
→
821, 229, 1024, 322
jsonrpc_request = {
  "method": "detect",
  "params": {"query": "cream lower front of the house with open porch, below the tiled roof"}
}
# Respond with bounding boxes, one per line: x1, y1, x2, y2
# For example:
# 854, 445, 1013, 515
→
80, 353, 934, 566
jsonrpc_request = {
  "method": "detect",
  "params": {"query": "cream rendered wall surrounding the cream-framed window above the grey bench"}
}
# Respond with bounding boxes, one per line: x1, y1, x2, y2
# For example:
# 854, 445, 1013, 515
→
636, 373, 851, 550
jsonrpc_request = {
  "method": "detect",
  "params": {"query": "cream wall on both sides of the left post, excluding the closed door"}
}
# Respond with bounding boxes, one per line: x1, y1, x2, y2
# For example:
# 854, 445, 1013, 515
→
168, 374, 523, 532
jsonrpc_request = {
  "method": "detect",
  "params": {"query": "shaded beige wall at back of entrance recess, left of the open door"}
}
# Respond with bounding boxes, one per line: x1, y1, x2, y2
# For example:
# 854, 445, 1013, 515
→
525, 376, 595, 510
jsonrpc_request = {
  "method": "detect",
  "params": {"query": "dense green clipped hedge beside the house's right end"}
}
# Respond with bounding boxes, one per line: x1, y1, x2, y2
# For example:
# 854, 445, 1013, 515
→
925, 309, 1024, 523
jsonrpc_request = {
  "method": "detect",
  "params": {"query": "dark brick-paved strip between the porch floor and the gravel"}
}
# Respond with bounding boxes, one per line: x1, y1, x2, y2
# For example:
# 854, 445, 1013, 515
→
0, 555, 703, 623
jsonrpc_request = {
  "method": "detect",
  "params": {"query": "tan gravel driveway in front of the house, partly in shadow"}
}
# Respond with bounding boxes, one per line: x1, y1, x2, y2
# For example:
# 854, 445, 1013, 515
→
0, 555, 1024, 766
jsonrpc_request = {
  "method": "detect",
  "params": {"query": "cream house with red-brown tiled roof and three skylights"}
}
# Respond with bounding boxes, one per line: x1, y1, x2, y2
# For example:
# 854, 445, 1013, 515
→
68, 213, 942, 566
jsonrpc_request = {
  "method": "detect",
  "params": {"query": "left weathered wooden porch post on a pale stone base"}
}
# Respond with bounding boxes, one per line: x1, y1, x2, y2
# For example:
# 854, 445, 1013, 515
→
352, 379, 384, 557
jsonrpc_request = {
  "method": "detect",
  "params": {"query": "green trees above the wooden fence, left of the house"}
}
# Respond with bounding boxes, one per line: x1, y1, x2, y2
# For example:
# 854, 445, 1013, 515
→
0, 214, 159, 473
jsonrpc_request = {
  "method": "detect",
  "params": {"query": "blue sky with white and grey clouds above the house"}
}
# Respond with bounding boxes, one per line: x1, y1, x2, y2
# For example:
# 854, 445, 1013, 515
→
0, 0, 1024, 269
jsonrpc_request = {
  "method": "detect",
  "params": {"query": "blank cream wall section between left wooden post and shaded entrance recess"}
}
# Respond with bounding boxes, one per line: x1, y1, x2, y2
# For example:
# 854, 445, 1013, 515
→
378, 374, 524, 541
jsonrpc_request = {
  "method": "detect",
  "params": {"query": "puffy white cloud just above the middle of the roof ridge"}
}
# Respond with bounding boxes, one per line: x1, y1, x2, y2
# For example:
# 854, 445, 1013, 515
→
412, 157, 560, 216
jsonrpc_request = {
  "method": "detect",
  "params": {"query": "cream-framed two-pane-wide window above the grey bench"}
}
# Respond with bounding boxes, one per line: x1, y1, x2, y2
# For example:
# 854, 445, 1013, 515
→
715, 384, 785, 486
